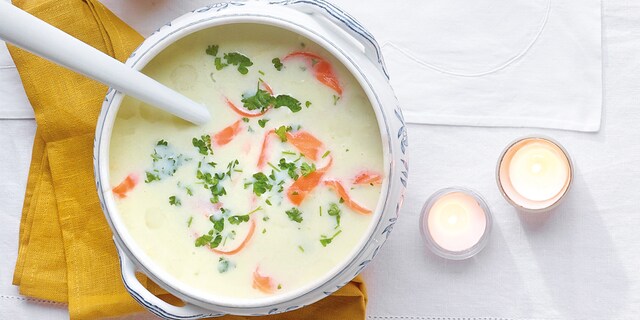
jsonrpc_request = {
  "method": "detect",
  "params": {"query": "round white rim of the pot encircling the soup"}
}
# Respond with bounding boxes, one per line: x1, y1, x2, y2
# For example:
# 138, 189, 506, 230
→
95, 3, 397, 309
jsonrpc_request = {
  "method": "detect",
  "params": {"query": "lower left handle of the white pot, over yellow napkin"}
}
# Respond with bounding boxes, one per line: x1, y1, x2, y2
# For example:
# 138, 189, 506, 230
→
116, 244, 224, 320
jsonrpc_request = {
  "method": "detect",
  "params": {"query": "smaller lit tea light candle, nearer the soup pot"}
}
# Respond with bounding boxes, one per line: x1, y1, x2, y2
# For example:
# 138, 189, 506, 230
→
420, 188, 492, 260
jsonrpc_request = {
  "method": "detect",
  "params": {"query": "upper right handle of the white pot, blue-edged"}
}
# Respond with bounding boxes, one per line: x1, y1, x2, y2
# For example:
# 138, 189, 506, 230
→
281, 0, 389, 79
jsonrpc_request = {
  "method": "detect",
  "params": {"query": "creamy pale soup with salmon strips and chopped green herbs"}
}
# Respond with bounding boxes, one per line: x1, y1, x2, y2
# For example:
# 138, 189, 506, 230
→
110, 24, 384, 298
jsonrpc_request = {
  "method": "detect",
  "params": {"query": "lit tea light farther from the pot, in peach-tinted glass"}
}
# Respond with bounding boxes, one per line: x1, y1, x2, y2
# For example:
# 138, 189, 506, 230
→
497, 137, 573, 212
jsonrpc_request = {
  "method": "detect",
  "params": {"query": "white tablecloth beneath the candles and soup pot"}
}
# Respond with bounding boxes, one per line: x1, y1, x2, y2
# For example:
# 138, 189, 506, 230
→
0, 0, 640, 320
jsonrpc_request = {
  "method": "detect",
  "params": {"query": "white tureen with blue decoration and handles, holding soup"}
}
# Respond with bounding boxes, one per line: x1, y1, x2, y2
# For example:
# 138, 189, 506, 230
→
94, 0, 408, 319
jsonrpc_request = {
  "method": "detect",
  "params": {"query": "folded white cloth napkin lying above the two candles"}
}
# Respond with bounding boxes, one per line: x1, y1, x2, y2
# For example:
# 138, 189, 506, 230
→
332, 0, 603, 131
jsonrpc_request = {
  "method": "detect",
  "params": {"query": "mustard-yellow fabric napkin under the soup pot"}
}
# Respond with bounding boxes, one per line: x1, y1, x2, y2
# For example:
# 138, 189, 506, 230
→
9, 0, 367, 319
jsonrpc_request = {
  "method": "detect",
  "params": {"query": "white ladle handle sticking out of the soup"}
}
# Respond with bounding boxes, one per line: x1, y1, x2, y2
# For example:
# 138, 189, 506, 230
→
0, 0, 211, 124
